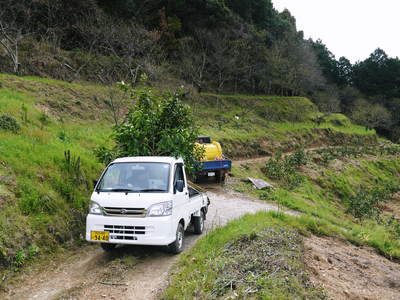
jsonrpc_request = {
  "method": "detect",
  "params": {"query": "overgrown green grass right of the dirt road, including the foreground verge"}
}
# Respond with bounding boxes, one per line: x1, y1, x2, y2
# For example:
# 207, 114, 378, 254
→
164, 145, 400, 299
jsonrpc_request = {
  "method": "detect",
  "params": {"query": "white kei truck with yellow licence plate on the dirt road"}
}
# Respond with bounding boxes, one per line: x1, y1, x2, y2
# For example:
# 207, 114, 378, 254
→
86, 157, 210, 254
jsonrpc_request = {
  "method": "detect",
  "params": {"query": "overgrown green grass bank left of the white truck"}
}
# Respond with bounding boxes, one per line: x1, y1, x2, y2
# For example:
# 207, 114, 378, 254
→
0, 82, 111, 267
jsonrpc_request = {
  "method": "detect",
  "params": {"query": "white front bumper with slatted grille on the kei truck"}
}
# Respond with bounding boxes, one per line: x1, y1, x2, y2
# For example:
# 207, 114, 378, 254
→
86, 214, 176, 246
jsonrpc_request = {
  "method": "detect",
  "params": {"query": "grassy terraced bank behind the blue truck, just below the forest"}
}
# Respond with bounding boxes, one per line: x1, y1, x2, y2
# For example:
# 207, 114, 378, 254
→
190, 94, 375, 158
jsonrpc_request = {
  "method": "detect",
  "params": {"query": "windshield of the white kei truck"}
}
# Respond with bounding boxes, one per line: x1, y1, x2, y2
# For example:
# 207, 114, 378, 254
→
97, 162, 170, 193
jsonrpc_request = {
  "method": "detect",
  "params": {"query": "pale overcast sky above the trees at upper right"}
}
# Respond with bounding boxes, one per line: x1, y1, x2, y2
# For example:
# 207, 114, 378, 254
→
272, 0, 400, 63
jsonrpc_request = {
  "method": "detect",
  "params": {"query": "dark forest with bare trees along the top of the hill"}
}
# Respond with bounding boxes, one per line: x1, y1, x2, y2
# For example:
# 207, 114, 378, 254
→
0, 0, 400, 142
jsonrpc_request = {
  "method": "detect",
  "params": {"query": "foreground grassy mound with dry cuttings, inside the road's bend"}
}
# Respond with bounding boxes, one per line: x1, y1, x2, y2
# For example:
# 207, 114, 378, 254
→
163, 212, 326, 299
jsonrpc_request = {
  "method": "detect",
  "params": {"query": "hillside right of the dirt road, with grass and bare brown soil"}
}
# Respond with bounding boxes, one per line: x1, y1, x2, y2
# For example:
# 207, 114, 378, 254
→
164, 131, 400, 299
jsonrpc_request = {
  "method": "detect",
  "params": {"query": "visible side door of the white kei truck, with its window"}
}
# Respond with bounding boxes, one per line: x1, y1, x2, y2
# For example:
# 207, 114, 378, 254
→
174, 163, 190, 226
